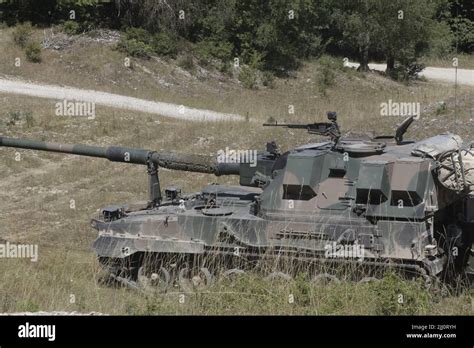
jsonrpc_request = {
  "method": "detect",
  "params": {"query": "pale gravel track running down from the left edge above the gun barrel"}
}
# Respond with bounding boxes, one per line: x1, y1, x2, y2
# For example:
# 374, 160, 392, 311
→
0, 78, 244, 121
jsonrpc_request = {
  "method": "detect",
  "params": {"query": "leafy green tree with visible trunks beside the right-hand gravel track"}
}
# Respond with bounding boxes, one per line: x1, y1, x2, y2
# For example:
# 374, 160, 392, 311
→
332, 0, 446, 75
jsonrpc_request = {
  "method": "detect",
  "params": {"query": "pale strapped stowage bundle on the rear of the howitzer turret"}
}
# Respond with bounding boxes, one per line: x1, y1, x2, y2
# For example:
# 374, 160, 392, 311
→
438, 142, 474, 193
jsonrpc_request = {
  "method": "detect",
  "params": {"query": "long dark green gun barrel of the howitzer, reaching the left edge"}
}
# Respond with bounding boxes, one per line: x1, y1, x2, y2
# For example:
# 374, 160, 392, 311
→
0, 137, 239, 176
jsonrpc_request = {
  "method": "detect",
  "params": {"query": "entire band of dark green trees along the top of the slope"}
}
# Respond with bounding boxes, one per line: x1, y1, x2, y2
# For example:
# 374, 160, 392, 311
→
0, 0, 474, 72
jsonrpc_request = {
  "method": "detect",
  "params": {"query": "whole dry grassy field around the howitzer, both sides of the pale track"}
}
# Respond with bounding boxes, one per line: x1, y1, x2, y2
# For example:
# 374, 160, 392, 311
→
0, 29, 474, 315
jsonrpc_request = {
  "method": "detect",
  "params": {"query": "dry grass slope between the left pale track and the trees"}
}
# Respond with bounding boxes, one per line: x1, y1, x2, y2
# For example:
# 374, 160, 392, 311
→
0, 29, 474, 131
